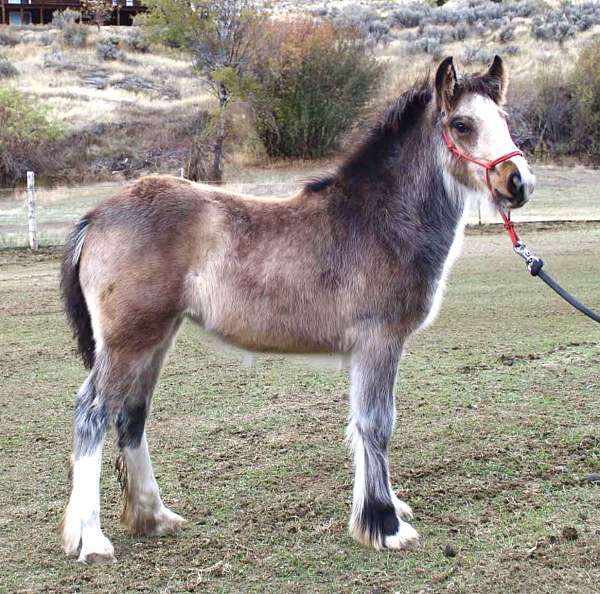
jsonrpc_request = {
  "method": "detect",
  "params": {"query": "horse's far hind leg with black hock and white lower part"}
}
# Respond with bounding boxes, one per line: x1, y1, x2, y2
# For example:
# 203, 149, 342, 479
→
116, 331, 185, 536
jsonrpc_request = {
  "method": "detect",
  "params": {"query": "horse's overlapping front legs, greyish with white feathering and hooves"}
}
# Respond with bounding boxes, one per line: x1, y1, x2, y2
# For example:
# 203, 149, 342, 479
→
348, 339, 419, 549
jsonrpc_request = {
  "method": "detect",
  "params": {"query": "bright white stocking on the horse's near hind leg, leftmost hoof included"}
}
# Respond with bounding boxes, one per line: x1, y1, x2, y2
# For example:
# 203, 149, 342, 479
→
62, 440, 114, 561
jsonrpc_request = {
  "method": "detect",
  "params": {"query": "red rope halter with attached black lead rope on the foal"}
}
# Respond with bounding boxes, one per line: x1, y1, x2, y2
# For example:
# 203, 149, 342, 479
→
442, 128, 600, 323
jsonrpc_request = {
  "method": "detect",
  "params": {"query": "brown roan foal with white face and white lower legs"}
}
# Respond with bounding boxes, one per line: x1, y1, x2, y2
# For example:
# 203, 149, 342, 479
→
60, 56, 535, 562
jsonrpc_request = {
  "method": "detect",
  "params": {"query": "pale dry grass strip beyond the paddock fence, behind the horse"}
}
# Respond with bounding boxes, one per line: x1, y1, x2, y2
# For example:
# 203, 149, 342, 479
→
0, 162, 600, 248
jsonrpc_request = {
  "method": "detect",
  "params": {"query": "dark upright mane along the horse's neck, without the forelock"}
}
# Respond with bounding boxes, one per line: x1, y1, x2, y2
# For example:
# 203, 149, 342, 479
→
304, 76, 433, 192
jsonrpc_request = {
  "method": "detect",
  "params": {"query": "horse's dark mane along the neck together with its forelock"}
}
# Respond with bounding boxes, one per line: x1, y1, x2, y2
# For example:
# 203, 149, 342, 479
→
304, 74, 500, 192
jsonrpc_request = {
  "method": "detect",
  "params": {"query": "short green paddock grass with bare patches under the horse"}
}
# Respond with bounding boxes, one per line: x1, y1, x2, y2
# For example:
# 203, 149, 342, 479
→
0, 212, 600, 594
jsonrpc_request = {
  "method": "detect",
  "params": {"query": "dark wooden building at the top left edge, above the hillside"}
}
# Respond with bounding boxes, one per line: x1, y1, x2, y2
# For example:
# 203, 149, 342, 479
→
0, 0, 144, 25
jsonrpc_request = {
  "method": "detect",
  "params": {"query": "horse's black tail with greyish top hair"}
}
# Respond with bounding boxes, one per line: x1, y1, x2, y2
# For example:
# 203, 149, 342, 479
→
60, 217, 96, 369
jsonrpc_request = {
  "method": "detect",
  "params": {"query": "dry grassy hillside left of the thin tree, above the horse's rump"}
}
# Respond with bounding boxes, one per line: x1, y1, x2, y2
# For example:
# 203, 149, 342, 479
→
0, 27, 209, 181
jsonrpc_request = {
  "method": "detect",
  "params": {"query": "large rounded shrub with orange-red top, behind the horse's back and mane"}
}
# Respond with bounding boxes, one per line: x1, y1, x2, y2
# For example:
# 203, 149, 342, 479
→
254, 20, 382, 158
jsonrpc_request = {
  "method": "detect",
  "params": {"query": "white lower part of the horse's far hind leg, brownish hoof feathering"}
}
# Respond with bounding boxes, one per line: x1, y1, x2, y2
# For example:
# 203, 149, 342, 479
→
123, 432, 185, 535
